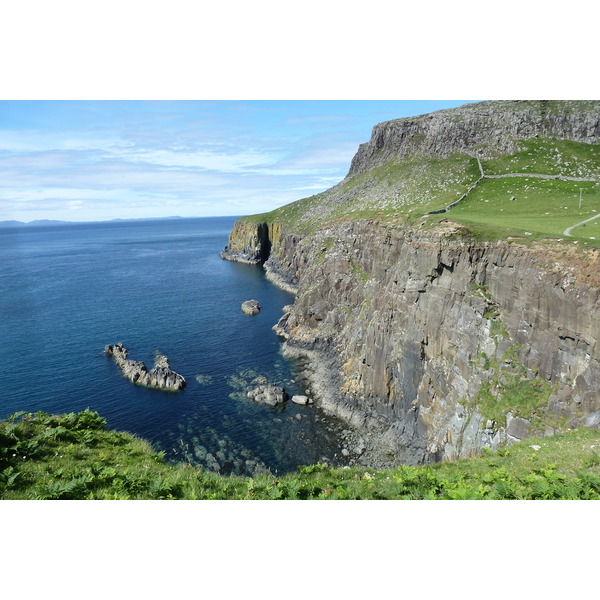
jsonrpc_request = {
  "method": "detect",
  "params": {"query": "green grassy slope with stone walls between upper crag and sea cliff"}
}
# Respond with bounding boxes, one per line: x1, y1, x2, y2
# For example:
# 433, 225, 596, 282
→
245, 138, 600, 247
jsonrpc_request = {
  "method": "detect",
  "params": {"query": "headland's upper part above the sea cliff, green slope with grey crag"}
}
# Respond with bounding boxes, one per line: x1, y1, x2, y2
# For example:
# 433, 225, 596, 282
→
239, 101, 600, 247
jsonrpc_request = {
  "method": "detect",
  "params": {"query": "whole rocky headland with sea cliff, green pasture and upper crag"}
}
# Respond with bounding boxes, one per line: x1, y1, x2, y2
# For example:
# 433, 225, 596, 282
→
224, 101, 600, 466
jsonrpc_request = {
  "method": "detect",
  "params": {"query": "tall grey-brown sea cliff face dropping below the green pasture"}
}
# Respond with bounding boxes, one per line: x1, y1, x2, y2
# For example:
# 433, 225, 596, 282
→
276, 221, 600, 463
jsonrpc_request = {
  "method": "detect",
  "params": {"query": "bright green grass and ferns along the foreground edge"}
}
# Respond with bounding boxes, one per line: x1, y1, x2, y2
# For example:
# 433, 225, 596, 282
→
0, 410, 600, 500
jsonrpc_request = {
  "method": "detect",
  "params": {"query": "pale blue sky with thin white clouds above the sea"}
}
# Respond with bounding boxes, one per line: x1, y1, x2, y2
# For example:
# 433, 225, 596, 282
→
0, 100, 478, 221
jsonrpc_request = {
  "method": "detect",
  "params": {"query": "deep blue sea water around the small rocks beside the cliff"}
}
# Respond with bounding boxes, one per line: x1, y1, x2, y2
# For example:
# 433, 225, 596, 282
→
0, 217, 339, 474
